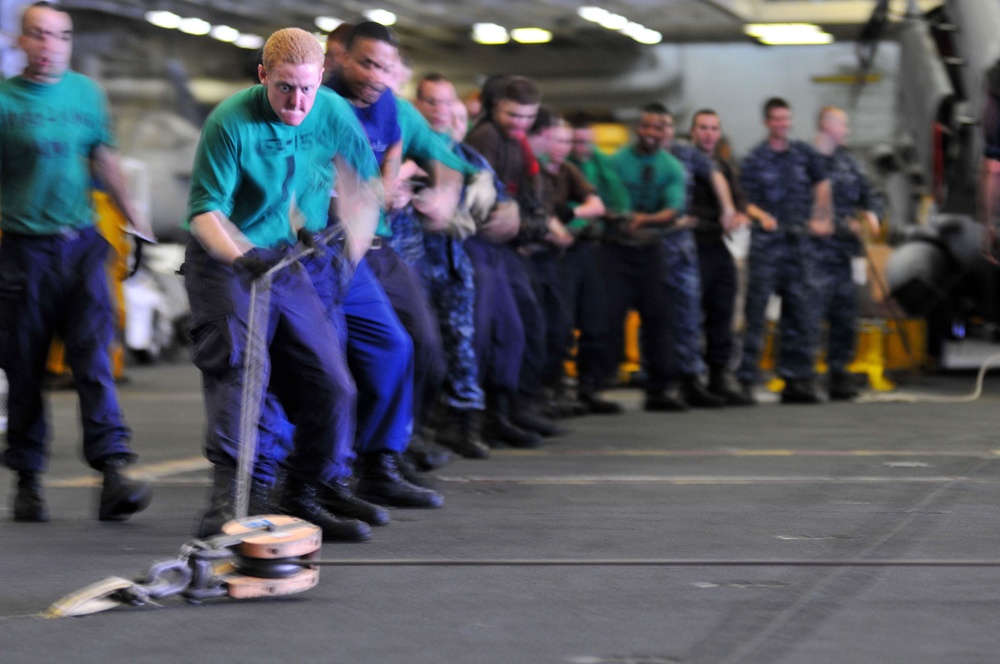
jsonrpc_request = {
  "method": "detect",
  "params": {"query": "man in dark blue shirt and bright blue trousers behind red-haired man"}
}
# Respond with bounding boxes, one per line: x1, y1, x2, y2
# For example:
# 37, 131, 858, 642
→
326, 21, 444, 507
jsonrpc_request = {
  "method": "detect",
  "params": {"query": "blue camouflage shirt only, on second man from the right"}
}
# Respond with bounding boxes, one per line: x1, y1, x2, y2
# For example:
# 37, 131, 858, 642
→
740, 141, 827, 230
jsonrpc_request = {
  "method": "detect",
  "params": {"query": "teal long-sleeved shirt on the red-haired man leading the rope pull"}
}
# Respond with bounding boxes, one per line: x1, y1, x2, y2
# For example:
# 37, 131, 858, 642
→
187, 85, 379, 247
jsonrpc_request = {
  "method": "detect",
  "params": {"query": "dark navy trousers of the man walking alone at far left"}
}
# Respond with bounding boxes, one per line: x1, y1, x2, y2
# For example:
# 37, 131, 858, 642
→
0, 227, 132, 472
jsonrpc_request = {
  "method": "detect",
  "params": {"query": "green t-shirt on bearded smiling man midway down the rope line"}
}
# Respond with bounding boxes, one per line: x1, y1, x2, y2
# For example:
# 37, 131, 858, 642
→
611, 145, 687, 215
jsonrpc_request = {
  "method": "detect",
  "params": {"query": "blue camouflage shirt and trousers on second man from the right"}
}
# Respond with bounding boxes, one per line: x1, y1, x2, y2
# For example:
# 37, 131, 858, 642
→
736, 141, 826, 385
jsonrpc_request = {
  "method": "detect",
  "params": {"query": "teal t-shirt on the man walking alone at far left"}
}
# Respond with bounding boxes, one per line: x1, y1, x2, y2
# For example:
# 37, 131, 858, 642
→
0, 71, 115, 235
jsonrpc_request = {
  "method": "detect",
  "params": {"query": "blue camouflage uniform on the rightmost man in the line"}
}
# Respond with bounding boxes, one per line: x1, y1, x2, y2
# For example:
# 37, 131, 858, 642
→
813, 147, 882, 376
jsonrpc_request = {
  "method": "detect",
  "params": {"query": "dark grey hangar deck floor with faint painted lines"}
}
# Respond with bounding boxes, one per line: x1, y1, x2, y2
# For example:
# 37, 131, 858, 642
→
0, 363, 1000, 664
